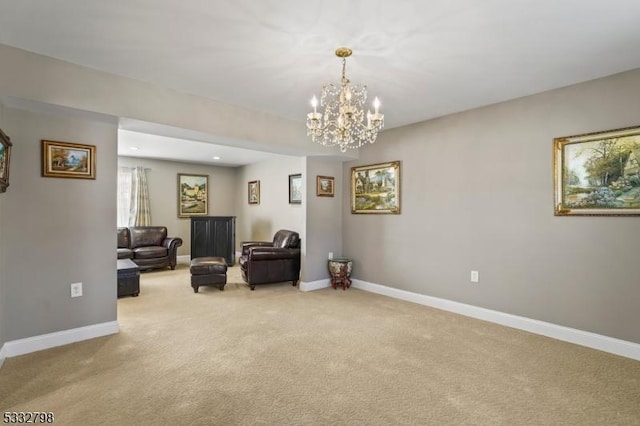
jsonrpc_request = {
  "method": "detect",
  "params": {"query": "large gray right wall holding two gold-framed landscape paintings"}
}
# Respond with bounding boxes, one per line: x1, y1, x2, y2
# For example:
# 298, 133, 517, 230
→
343, 70, 640, 343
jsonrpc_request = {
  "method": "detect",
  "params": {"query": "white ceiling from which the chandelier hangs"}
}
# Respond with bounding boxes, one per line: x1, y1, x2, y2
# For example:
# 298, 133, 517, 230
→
0, 0, 640, 165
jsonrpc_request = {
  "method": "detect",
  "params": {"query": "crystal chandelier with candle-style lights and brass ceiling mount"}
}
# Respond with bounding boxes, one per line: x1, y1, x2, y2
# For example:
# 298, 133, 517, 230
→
307, 47, 384, 152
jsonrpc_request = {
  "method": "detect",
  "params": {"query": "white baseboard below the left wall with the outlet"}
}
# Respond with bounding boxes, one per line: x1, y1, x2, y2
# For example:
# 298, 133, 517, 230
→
0, 321, 120, 358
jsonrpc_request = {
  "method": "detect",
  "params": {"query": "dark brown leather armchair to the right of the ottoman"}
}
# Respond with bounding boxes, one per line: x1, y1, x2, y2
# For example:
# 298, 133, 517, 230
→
240, 229, 300, 290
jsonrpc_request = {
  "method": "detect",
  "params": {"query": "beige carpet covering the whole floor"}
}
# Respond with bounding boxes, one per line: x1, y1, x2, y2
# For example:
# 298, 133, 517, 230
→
0, 265, 640, 426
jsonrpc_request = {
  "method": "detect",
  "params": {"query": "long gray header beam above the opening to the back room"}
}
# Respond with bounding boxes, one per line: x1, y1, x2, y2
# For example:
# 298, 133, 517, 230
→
0, 44, 338, 159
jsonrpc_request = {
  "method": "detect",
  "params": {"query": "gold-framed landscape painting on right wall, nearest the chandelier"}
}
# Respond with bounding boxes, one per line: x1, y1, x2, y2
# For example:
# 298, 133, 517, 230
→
351, 161, 400, 214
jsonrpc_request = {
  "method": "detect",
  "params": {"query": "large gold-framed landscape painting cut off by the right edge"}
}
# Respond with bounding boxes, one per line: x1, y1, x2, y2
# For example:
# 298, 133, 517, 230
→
553, 126, 640, 216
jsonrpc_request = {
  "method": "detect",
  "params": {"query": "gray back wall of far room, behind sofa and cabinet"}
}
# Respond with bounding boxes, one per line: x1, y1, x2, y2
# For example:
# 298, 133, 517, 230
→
118, 156, 238, 255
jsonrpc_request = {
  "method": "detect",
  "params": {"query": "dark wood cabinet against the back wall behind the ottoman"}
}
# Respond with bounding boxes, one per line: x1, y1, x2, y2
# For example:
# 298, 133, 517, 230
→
191, 216, 236, 266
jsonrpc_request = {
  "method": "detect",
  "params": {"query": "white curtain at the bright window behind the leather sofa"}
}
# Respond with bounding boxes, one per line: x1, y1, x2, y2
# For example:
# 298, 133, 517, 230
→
118, 167, 151, 226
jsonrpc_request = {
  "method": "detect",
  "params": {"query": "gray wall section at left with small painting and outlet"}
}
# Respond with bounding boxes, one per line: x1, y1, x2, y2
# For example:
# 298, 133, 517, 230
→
0, 108, 117, 341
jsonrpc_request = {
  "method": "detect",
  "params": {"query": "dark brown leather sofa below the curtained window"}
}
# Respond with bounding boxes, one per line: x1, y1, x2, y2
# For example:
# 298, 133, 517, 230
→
118, 226, 182, 270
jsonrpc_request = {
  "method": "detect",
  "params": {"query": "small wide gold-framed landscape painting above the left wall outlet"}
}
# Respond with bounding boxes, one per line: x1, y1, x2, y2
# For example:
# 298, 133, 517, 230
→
42, 140, 96, 179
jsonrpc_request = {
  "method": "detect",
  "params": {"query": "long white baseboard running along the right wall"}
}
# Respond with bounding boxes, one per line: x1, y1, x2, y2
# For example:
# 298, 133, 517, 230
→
352, 279, 640, 361
